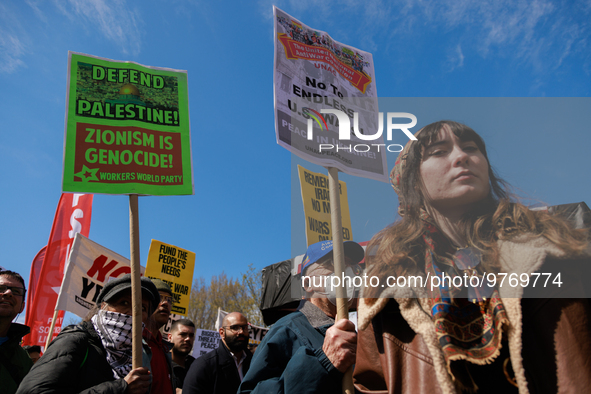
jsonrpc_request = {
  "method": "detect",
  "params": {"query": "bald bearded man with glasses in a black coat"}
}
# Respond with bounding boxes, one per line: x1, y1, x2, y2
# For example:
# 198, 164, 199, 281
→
183, 312, 252, 394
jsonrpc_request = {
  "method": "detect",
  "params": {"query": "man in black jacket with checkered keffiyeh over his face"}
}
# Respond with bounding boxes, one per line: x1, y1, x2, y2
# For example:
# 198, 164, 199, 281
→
17, 274, 160, 394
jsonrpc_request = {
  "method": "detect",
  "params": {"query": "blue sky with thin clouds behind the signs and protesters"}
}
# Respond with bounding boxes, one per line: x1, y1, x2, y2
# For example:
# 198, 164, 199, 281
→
0, 0, 591, 320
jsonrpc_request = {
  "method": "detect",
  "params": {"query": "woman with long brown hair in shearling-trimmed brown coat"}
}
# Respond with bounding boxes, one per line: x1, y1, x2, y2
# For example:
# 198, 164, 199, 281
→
354, 121, 591, 393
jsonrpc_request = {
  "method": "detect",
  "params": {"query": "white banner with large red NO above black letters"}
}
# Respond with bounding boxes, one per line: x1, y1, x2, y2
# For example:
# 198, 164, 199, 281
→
56, 233, 145, 318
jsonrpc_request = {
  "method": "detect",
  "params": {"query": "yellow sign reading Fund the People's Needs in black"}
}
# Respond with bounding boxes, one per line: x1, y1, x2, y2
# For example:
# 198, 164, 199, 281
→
145, 239, 195, 316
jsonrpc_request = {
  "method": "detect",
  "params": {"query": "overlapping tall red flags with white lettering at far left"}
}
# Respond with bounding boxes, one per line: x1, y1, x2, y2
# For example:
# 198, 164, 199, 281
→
23, 193, 93, 347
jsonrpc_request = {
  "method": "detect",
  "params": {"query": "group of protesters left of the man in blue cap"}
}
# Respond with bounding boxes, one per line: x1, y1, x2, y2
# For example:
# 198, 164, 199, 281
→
0, 270, 253, 394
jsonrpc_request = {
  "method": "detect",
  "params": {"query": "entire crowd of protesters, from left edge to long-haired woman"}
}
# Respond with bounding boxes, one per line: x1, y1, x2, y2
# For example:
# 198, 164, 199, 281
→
0, 121, 591, 394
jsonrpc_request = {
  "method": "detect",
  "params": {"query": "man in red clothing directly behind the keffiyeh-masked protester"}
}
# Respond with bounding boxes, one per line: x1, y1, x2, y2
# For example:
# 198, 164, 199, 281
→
142, 279, 175, 394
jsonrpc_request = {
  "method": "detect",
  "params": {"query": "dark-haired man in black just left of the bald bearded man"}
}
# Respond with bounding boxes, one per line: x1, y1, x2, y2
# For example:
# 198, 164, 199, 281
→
168, 319, 195, 392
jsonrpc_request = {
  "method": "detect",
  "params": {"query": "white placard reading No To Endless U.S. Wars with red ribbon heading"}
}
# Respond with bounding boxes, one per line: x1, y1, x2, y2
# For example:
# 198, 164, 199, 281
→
273, 7, 391, 182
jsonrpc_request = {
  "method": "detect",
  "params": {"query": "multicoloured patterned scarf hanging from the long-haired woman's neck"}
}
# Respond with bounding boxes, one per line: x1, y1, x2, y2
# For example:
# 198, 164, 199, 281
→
421, 211, 510, 383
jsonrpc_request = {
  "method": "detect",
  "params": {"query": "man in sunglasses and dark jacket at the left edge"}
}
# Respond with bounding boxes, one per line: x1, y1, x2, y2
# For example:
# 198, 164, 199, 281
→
0, 270, 33, 394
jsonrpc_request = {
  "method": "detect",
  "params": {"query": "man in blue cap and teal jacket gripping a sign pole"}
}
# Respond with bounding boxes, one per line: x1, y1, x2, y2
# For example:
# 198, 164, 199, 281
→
239, 241, 364, 394
